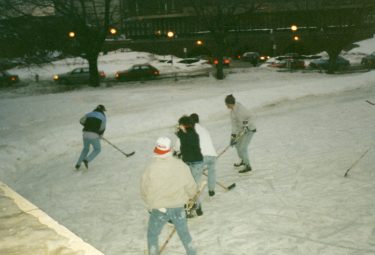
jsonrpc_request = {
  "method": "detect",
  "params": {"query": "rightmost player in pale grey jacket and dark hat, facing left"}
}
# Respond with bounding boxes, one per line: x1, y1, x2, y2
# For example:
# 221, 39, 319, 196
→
225, 94, 256, 173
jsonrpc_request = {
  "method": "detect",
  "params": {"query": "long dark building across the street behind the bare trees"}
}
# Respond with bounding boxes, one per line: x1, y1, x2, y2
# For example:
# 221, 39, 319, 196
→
110, 0, 375, 56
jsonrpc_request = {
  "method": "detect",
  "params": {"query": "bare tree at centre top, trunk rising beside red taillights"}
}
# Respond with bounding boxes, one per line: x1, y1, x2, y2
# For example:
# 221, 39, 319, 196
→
189, 0, 262, 80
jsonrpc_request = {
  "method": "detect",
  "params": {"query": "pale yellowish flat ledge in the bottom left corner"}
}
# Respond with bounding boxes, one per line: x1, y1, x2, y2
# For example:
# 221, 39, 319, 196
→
0, 182, 104, 255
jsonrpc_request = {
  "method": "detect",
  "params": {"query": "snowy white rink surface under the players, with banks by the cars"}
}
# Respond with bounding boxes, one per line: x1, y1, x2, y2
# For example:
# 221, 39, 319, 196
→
0, 34, 375, 255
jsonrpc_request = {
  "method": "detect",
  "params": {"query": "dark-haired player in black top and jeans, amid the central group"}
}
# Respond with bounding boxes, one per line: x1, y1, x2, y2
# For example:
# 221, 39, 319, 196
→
176, 116, 204, 217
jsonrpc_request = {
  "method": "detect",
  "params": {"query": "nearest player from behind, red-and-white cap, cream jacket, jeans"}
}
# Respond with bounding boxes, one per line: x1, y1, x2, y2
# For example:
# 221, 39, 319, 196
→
141, 137, 198, 255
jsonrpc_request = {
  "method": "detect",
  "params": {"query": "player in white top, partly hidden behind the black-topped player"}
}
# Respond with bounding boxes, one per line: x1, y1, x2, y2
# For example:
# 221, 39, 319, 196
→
190, 113, 217, 197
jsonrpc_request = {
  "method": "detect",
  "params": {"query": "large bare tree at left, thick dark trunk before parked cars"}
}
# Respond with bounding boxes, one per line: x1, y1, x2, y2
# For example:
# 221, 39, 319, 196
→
0, 0, 118, 86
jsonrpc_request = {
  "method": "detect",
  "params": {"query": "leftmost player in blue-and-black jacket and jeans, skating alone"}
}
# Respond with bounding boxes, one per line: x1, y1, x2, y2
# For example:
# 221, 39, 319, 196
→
75, 104, 107, 170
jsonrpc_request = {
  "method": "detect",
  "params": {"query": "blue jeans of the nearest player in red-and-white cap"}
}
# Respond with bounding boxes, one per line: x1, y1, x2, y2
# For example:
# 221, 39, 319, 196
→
147, 207, 197, 255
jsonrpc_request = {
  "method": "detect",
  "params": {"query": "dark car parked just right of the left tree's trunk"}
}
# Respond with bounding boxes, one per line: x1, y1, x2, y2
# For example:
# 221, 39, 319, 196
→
115, 64, 160, 81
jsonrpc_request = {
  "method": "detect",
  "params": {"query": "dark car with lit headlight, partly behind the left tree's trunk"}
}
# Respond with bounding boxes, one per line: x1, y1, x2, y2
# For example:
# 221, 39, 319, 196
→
53, 67, 105, 84
